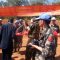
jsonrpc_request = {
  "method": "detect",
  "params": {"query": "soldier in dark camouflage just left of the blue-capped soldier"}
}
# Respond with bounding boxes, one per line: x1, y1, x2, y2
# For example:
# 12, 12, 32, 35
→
25, 18, 39, 60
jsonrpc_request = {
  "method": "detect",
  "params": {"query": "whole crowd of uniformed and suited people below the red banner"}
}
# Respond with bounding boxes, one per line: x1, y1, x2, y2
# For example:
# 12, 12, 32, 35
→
0, 13, 60, 60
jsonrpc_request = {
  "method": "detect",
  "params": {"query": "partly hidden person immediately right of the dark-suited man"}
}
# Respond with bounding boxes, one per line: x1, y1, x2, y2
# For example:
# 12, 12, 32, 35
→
13, 20, 19, 52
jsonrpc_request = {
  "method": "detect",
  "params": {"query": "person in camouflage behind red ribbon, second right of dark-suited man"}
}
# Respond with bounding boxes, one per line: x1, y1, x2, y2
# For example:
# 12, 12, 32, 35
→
16, 19, 24, 52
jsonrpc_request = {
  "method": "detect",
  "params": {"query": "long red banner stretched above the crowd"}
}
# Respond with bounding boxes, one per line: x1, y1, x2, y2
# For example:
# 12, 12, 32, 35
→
0, 5, 60, 16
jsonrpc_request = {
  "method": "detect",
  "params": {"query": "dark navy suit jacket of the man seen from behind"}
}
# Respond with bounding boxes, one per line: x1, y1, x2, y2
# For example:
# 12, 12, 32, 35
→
1, 24, 13, 49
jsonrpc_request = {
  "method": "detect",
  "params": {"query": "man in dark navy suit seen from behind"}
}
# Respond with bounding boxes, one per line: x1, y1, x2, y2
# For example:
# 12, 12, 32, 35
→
1, 19, 13, 60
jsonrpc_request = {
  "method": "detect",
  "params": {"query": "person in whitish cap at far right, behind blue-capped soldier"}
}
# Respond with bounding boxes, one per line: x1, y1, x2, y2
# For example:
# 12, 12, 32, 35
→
50, 17, 60, 58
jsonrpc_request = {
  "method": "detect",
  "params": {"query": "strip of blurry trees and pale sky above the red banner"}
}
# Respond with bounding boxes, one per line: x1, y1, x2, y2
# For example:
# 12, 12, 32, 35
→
0, 0, 60, 6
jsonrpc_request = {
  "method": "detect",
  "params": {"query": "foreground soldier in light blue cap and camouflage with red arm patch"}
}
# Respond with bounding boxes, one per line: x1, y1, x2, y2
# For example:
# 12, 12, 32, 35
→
29, 13, 54, 60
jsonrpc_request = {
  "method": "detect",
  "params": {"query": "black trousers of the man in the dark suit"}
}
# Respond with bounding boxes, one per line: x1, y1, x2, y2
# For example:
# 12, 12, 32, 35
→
2, 48, 13, 60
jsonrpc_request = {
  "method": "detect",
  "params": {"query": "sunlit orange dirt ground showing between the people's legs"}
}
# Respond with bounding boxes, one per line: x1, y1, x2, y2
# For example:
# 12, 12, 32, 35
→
0, 36, 60, 60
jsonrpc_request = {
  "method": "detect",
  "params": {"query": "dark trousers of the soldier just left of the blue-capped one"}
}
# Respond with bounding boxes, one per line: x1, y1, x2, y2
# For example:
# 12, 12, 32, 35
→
25, 46, 36, 60
